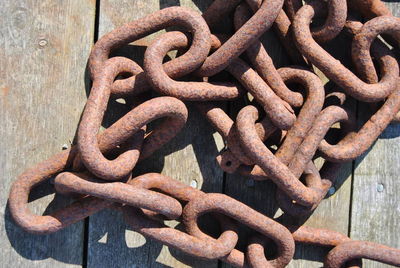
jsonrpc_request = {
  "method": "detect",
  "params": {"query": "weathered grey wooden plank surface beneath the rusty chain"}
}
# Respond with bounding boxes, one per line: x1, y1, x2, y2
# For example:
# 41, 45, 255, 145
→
0, 0, 400, 268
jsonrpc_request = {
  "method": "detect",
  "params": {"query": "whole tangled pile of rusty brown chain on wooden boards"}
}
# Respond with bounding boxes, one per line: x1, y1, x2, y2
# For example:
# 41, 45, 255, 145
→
9, 0, 400, 267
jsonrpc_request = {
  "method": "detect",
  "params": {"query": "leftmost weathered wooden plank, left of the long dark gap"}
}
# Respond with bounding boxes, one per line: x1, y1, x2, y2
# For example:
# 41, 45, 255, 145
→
0, 0, 95, 267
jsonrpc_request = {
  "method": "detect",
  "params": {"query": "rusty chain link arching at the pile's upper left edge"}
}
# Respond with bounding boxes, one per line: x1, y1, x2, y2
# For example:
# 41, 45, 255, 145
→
98, 7, 216, 96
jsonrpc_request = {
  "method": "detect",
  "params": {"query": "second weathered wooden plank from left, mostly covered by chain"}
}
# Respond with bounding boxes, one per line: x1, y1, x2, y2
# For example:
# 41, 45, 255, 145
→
87, 0, 223, 267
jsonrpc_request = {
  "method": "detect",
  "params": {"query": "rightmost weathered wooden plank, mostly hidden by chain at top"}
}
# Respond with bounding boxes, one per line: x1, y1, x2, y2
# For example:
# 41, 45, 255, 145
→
350, 2, 400, 267
